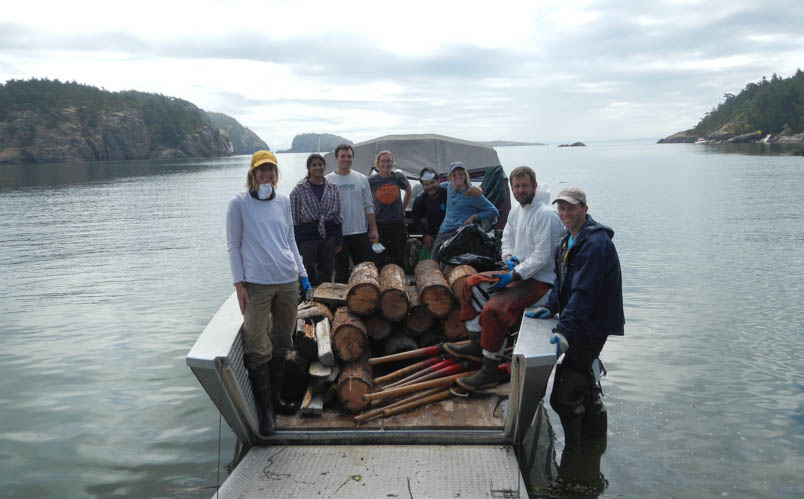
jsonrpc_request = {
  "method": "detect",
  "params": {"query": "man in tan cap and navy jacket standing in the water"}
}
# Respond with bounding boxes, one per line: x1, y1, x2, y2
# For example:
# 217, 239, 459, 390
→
527, 187, 625, 444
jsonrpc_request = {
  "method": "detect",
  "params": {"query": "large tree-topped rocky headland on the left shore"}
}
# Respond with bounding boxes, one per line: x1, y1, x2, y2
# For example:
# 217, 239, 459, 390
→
0, 79, 268, 163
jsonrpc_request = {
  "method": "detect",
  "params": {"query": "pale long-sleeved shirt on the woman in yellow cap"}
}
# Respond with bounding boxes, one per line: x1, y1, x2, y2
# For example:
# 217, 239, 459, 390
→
226, 192, 307, 284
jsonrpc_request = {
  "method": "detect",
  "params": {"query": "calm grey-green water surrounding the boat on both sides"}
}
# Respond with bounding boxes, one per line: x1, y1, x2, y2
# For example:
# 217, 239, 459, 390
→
0, 144, 804, 497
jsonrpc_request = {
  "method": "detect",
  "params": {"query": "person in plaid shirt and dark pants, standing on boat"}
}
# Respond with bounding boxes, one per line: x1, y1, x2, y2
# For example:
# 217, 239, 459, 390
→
290, 154, 343, 286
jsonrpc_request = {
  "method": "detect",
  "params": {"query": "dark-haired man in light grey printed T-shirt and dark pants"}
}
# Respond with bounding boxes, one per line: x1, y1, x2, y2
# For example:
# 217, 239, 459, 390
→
326, 144, 379, 282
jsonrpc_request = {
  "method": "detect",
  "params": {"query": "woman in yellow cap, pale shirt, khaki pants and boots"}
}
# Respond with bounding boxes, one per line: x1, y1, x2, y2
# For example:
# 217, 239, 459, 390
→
226, 151, 310, 436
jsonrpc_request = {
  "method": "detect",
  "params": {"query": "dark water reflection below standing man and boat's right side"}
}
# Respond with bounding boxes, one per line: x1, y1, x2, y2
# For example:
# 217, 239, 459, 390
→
520, 405, 609, 499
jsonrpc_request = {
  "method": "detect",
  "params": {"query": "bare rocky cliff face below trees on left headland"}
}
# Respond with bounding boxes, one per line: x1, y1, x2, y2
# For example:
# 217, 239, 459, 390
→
0, 107, 232, 163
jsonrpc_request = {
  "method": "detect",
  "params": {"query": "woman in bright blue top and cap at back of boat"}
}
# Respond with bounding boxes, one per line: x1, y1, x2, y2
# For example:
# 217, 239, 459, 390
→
433, 161, 500, 263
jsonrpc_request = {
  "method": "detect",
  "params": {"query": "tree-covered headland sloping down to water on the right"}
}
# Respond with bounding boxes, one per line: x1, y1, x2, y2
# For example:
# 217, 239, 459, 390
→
658, 69, 804, 144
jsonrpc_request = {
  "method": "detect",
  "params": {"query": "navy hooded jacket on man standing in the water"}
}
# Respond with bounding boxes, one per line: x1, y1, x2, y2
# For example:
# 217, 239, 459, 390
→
546, 215, 625, 345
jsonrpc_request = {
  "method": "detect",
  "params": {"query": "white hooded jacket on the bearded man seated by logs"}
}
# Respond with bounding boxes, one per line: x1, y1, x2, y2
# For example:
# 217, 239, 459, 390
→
502, 195, 564, 284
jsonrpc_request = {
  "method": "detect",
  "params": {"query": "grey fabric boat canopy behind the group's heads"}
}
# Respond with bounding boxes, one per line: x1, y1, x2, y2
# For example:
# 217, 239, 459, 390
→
324, 133, 500, 178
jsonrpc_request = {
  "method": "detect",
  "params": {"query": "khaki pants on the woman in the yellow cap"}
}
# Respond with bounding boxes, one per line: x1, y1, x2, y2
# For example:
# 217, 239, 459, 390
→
243, 281, 299, 369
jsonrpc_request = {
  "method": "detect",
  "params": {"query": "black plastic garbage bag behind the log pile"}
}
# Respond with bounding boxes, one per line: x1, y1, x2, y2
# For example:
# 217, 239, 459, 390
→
439, 225, 505, 272
